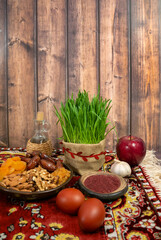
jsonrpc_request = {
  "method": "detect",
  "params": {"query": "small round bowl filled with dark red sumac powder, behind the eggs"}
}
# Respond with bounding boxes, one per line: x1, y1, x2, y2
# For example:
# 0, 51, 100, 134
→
79, 171, 128, 201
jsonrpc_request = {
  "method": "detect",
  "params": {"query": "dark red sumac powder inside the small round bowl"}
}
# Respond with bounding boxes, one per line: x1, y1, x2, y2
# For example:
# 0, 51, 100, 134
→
84, 174, 120, 193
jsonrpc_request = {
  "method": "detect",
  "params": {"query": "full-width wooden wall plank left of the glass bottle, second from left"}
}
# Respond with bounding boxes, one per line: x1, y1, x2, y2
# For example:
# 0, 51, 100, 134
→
7, 0, 36, 147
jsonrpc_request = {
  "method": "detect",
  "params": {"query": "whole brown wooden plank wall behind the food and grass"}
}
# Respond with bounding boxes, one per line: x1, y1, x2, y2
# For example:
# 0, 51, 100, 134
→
0, 0, 161, 151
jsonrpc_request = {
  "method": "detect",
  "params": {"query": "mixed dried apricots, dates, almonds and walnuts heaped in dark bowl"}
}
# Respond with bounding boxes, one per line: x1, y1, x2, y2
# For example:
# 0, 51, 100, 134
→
0, 151, 70, 192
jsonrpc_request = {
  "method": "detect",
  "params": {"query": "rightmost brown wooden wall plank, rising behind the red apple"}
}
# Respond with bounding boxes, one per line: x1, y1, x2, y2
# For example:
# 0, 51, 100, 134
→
131, 0, 161, 150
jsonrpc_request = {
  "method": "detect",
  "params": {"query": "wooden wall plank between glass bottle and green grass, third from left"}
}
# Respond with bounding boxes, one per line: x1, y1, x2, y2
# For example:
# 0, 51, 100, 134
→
38, 0, 66, 147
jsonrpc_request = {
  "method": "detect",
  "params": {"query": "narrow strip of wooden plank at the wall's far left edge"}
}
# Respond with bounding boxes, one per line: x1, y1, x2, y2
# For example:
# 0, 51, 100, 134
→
0, 0, 8, 146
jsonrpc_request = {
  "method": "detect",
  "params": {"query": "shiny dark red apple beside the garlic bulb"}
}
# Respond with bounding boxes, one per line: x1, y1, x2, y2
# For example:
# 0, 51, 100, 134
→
116, 136, 146, 167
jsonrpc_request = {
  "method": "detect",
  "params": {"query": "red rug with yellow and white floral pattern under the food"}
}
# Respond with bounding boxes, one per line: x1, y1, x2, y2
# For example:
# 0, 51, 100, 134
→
0, 149, 161, 240
